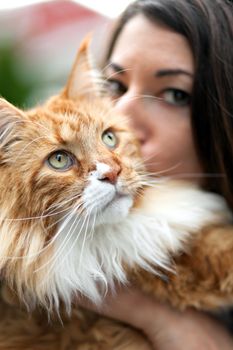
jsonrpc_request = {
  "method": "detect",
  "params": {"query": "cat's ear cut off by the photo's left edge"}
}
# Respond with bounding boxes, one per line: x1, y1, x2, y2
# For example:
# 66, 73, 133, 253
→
0, 98, 24, 145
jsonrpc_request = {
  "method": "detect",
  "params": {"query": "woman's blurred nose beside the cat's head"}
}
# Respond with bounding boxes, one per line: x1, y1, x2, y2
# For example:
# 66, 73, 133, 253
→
115, 93, 147, 143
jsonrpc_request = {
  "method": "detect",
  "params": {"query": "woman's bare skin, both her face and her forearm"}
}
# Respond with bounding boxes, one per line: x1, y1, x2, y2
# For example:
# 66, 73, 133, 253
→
89, 15, 233, 350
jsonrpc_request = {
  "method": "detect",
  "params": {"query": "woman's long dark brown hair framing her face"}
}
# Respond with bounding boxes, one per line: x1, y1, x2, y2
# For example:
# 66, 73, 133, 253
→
105, 0, 233, 208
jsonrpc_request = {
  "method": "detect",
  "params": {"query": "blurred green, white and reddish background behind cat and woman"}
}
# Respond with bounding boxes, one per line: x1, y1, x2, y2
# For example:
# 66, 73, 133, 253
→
0, 0, 134, 108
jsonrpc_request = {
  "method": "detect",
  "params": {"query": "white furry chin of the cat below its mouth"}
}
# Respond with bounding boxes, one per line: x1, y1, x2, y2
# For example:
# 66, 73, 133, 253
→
93, 194, 133, 226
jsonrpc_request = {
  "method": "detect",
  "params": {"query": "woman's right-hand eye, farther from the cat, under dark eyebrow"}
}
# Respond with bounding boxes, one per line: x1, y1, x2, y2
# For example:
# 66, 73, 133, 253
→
160, 88, 191, 106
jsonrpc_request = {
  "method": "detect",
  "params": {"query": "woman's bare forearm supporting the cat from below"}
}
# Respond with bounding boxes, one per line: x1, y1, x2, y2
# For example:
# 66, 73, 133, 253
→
93, 287, 233, 350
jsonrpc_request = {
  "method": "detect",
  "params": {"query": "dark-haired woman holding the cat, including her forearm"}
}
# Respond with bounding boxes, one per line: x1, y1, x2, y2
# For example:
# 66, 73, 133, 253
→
89, 0, 233, 350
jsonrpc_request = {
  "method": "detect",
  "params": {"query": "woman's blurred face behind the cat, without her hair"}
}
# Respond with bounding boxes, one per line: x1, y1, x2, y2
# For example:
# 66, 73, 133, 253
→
107, 15, 203, 180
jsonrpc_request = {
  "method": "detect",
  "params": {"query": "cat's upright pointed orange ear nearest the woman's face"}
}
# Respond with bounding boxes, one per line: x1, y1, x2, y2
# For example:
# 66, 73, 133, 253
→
62, 35, 101, 100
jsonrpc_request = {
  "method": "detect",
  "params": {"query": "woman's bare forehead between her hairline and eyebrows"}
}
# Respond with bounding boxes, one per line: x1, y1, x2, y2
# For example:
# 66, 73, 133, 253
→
110, 15, 194, 73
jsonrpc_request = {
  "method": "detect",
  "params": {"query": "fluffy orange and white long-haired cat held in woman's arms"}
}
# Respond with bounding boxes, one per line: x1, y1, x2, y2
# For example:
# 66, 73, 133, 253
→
0, 39, 233, 350
